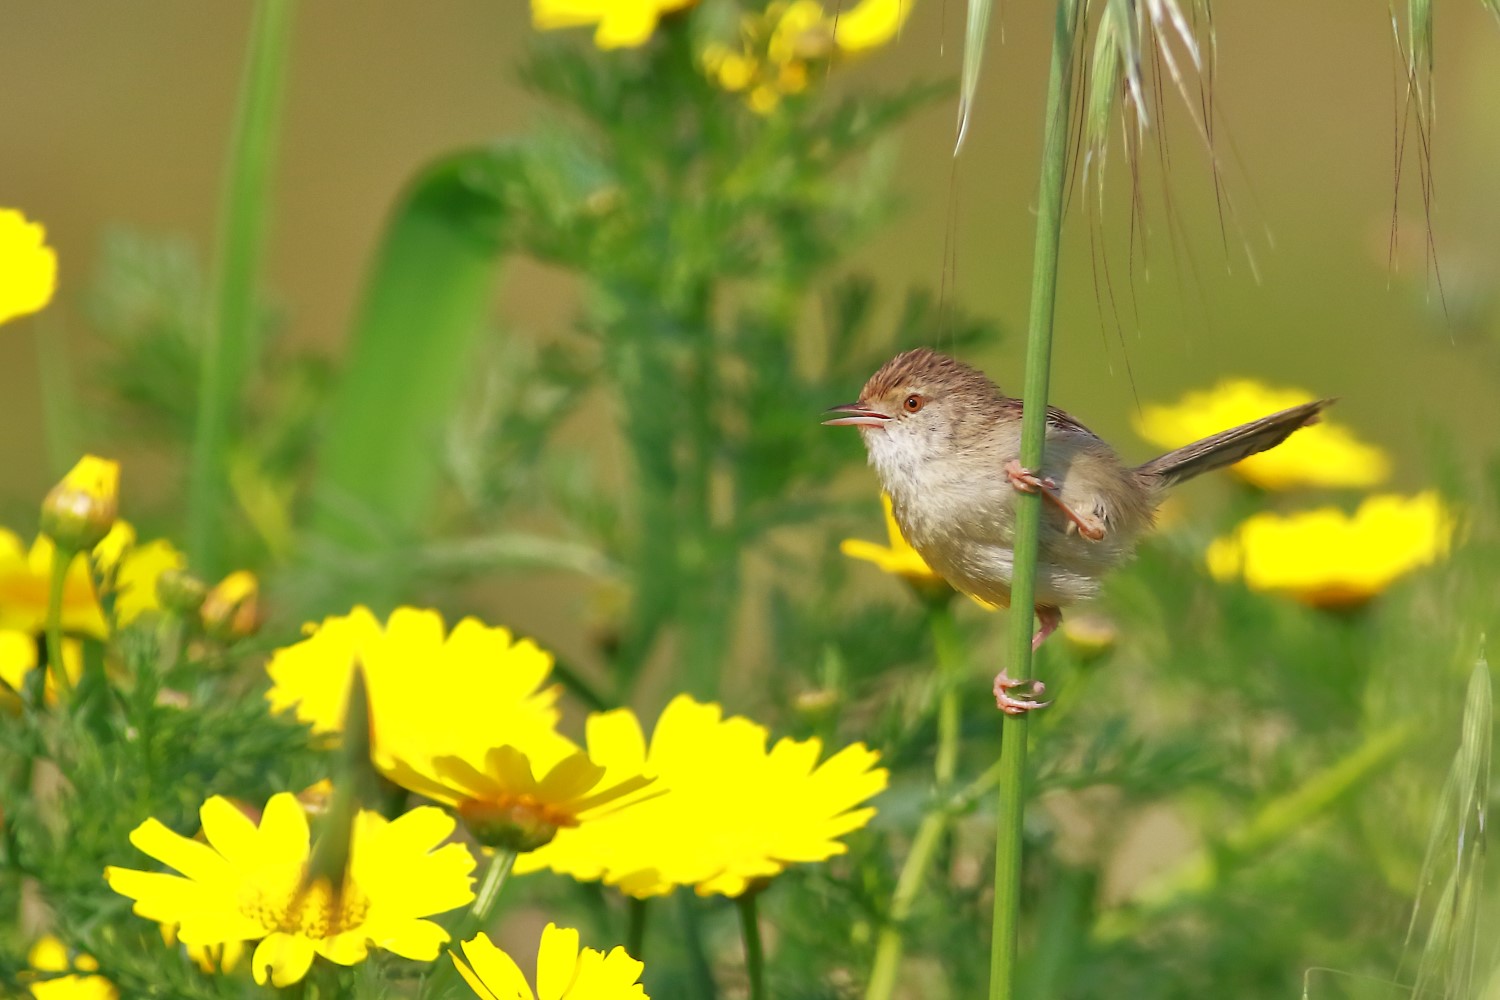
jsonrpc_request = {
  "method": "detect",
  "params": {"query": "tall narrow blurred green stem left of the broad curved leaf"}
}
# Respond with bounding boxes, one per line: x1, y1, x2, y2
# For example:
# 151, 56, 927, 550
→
188, 0, 294, 579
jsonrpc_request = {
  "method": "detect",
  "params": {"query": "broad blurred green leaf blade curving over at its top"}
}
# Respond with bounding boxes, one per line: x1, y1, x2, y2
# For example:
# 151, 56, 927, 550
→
312, 148, 518, 553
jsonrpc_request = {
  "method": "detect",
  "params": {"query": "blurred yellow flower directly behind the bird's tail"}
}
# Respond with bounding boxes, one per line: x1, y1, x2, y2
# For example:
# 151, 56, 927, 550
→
1136, 379, 1391, 490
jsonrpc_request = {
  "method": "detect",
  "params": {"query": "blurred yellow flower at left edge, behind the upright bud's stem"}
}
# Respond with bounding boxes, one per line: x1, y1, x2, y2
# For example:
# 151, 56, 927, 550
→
0, 520, 186, 639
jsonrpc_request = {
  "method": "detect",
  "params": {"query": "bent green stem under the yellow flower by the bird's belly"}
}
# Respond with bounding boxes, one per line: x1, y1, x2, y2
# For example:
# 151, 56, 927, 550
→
864, 600, 966, 1000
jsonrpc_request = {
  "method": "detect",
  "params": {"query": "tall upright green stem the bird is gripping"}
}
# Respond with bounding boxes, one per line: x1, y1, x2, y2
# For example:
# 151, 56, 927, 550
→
990, 0, 1079, 1000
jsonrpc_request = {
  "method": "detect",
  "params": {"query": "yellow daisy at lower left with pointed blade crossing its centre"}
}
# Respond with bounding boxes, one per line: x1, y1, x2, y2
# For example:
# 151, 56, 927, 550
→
105, 792, 474, 987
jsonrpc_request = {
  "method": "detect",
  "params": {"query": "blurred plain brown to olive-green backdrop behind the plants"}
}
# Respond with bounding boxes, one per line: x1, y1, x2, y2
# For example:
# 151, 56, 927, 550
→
0, 0, 1500, 683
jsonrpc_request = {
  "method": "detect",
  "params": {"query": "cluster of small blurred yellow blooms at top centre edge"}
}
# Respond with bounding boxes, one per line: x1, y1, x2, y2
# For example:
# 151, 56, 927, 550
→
699, 0, 912, 114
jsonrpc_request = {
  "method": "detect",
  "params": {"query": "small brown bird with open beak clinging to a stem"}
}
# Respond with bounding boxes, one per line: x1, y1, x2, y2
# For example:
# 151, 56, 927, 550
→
824, 348, 1334, 714
